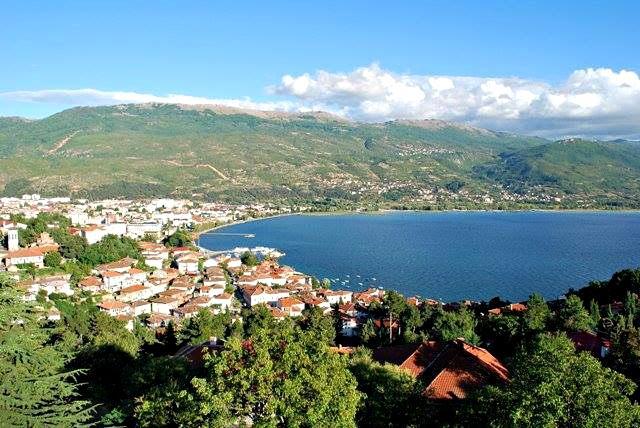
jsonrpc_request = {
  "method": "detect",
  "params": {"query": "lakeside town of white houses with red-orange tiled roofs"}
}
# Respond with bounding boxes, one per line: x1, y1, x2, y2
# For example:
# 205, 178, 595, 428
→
0, 195, 621, 398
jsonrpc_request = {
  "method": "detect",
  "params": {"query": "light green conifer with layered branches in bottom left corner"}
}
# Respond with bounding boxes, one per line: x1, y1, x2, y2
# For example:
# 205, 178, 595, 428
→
0, 276, 93, 426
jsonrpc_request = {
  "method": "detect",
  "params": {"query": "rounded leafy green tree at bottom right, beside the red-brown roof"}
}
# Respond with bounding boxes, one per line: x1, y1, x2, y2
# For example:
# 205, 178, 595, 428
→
467, 334, 640, 427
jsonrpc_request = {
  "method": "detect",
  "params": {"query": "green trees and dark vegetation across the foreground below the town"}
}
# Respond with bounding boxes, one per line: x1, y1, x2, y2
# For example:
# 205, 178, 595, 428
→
0, 260, 640, 427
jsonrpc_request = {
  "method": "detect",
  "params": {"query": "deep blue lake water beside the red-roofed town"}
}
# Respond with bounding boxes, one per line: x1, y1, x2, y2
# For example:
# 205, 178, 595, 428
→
200, 212, 640, 301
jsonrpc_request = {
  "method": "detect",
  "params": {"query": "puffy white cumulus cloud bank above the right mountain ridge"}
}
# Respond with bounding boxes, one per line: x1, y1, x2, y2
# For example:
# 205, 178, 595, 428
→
270, 64, 640, 138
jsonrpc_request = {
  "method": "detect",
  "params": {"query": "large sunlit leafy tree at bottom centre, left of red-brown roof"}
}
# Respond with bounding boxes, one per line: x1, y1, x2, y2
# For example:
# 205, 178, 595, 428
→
137, 322, 360, 427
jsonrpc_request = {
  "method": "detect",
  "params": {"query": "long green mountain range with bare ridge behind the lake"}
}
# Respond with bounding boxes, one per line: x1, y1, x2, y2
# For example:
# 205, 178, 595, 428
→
0, 104, 640, 207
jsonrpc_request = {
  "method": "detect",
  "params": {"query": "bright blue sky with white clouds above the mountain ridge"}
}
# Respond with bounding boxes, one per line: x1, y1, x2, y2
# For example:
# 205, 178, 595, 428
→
0, 0, 640, 139
